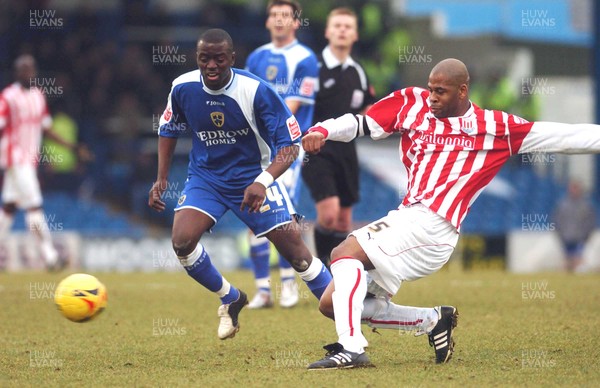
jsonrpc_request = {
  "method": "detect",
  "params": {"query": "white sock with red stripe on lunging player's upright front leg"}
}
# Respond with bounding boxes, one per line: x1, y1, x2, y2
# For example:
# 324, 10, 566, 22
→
331, 259, 368, 353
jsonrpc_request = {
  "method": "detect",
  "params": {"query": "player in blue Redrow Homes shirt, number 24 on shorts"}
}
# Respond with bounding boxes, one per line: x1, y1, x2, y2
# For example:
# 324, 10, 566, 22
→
148, 29, 331, 339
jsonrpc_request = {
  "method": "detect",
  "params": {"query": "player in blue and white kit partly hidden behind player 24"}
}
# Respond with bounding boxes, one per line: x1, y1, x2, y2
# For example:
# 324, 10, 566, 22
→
246, 0, 319, 308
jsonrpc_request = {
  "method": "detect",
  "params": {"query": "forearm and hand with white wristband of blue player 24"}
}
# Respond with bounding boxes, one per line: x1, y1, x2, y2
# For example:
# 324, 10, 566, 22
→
240, 144, 300, 213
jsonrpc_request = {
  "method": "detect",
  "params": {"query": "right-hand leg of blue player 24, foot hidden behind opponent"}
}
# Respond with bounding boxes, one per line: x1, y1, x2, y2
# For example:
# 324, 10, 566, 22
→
266, 220, 331, 299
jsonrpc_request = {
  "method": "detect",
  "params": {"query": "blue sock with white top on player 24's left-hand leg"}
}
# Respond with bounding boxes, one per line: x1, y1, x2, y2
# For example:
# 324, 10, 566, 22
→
179, 244, 240, 304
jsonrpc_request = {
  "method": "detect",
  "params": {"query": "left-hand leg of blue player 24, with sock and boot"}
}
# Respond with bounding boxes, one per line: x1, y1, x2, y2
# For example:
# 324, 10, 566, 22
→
172, 209, 248, 339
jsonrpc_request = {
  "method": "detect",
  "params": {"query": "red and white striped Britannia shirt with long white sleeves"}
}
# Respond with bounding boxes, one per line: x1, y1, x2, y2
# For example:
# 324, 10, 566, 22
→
315, 87, 600, 230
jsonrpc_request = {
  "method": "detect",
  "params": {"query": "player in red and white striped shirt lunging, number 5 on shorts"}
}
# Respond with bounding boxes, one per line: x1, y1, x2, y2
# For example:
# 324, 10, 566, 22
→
302, 59, 600, 369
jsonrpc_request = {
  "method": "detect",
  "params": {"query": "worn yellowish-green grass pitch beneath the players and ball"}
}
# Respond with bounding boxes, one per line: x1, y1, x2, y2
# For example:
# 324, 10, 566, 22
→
0, 270, 600, 387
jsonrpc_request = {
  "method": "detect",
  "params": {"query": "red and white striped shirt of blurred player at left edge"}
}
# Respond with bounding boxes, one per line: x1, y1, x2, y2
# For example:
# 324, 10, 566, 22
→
0, 82, 52, 169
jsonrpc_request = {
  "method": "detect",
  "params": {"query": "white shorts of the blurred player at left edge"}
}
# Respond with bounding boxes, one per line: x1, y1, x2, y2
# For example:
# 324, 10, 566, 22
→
2, 165, 42, 209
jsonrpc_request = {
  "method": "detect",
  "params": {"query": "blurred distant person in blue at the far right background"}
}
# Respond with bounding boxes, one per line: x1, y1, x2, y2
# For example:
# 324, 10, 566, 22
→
554, 181, 596, 272
